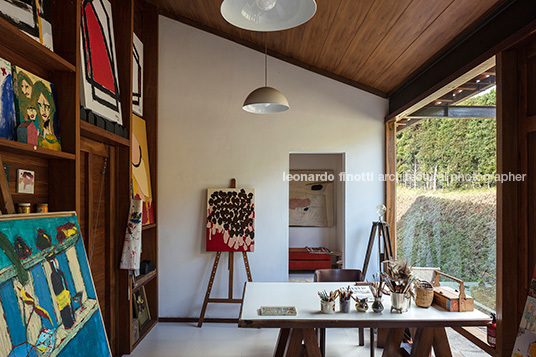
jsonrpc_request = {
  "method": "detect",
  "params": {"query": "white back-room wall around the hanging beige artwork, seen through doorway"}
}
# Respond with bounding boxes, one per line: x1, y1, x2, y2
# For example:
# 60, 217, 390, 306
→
288, 153, 344, 252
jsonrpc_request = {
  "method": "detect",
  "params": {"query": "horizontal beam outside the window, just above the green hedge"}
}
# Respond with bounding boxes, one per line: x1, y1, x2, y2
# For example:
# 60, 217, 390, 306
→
408, 105, 496, 119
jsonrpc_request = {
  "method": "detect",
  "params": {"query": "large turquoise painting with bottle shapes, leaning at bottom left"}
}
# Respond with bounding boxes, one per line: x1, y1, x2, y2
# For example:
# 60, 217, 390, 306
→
0, 213, 111, 357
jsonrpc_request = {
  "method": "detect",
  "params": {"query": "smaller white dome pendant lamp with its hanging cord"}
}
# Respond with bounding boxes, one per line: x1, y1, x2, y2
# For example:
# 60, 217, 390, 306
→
242, 42, 289, 114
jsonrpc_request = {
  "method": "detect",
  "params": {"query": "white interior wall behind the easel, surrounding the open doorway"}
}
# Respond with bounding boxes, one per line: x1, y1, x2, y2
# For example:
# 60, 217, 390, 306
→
157, 17, 387, 317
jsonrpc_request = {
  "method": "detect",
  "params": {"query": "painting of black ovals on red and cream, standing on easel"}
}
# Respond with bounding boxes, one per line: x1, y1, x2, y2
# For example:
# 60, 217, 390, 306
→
207, 188, 255, 252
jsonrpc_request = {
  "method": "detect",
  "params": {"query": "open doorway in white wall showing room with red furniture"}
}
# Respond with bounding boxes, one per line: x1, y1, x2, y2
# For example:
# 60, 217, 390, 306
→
287, 153, 345, 281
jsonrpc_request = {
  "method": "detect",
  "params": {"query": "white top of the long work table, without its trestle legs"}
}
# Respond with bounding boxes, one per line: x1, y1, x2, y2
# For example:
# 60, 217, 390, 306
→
238, 282, 490, 328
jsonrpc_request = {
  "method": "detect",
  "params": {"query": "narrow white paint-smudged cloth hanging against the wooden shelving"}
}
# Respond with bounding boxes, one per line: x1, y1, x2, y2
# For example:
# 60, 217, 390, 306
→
120, 199, 143, 270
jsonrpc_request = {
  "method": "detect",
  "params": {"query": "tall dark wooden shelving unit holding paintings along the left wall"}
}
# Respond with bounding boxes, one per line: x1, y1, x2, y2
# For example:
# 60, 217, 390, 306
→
0, 0, 158, 356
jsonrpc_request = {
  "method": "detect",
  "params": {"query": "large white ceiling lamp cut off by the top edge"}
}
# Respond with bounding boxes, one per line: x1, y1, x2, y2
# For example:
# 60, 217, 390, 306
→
220, 0, 316, 32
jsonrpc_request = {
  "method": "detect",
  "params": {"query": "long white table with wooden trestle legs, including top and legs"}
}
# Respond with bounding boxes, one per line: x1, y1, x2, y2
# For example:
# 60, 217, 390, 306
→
238, 282, 490, 357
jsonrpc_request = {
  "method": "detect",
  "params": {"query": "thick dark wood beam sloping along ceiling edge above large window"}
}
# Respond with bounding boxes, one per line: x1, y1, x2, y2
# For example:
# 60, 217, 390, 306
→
386, 0, 536, 121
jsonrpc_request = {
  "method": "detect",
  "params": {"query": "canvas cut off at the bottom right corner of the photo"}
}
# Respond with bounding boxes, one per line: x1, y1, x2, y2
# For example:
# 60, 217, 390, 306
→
512, 270, 536, 357
